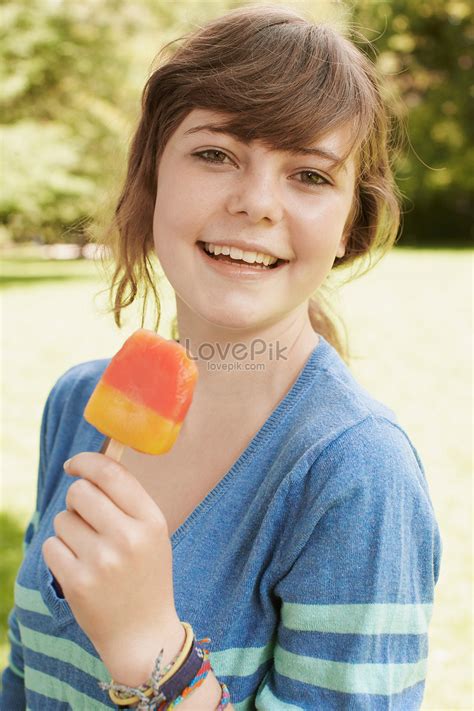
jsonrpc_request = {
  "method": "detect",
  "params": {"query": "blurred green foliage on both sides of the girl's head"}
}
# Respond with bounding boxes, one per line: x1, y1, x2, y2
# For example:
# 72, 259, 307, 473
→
0, 0, 474, 245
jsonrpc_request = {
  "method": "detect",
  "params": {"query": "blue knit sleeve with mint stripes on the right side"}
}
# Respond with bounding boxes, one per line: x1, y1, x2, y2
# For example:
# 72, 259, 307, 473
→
256, 415, 442, 711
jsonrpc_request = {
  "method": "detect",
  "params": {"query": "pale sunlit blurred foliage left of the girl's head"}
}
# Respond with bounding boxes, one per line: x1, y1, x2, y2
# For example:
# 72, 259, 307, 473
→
0, 0, 135, 239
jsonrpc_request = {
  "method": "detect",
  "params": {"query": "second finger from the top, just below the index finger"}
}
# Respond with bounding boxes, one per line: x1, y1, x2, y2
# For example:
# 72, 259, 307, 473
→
66, 478, 130, 534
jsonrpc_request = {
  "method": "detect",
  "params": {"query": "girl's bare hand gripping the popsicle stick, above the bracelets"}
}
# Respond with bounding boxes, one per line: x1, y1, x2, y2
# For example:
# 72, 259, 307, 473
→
42, 452, 184, 684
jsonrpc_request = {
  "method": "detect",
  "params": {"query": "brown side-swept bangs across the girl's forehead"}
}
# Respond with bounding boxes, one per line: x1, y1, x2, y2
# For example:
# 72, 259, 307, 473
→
171, 22, 376, 162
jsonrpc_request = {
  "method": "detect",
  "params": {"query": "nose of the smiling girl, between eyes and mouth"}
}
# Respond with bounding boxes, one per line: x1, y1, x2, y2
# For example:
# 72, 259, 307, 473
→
227, 167, 283, 224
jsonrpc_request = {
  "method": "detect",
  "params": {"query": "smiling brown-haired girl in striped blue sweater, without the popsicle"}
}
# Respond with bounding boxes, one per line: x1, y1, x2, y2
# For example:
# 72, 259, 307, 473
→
2, 6, 441, 711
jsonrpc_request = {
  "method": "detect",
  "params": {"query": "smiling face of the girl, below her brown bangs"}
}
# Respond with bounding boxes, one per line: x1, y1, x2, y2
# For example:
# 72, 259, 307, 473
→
153, 109, 355, 331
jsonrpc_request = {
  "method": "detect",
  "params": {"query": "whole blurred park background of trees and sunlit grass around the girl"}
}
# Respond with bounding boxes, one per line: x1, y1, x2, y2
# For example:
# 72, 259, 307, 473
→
0, 0, 474, 711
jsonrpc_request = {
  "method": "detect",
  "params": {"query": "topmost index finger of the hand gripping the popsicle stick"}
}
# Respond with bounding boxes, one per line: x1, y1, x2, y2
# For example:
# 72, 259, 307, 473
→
64, 452, 163, 520
